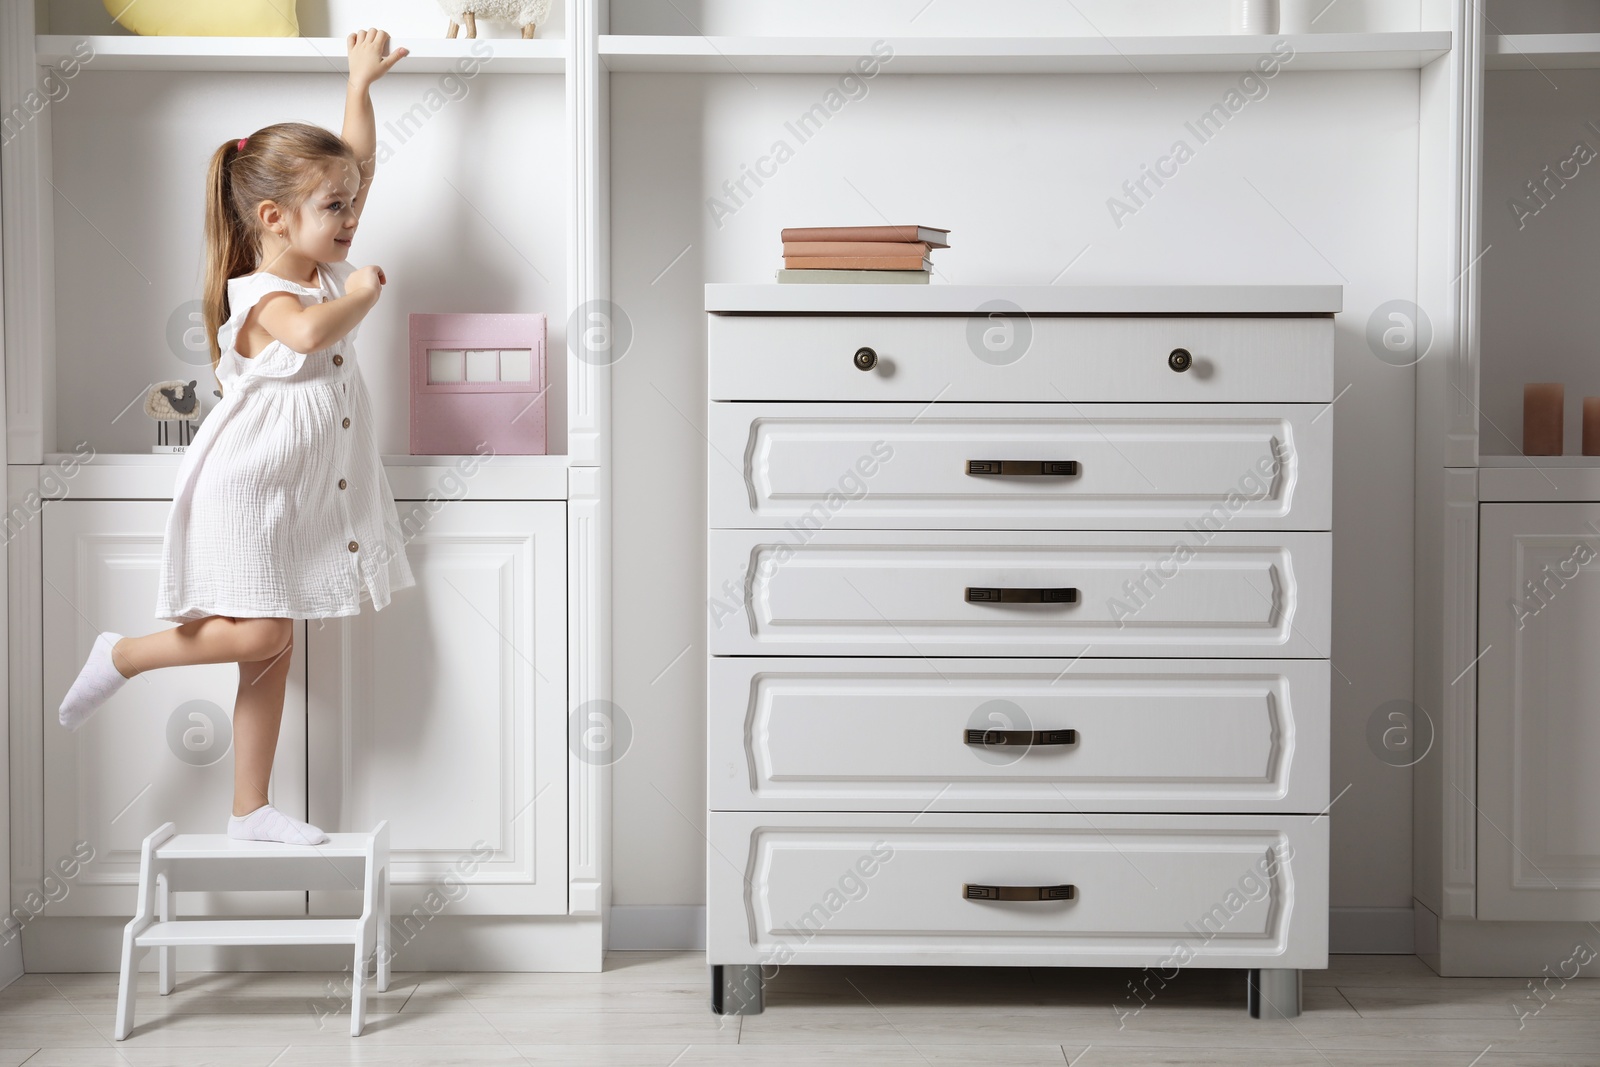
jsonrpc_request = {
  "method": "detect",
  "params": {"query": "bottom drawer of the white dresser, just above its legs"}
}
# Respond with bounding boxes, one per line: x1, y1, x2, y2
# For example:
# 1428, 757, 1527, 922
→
706, 811, 1328, 968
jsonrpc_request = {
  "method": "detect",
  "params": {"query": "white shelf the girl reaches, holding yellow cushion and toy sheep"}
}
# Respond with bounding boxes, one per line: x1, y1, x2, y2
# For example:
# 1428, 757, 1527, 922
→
34, 34, 566, 74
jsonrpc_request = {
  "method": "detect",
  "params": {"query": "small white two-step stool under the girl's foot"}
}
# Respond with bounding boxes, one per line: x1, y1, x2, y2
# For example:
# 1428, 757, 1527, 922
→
117, 819, 389, 1041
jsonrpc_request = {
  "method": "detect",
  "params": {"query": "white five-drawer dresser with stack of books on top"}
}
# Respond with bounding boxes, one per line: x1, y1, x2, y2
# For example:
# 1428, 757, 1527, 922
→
706, 285, 1342, 1016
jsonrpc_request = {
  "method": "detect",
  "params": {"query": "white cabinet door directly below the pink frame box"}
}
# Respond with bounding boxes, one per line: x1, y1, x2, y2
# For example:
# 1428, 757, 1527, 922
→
309, 501, 566, 917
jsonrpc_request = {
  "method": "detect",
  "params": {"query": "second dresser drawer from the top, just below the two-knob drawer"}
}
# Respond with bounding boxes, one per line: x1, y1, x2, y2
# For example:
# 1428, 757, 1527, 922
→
709, 403, 1333, 530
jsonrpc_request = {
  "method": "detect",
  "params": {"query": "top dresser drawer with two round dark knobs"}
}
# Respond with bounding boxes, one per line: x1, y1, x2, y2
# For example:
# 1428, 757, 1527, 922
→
707, 315, 1333, 403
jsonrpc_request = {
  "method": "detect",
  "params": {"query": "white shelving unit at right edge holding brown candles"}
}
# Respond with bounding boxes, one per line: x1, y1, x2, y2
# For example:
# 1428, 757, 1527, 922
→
1413, 0, 1600, 976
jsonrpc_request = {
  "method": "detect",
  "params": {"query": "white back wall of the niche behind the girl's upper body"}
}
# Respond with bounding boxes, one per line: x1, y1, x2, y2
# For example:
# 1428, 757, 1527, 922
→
50, 64, 566, 454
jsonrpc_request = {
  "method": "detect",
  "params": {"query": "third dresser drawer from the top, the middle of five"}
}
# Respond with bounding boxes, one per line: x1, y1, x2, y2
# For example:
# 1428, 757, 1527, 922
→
707, 530, 1333, 659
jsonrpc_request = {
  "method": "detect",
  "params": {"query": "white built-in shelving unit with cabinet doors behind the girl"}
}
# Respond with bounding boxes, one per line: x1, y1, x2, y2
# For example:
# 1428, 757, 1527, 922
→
0, 0, 610, 971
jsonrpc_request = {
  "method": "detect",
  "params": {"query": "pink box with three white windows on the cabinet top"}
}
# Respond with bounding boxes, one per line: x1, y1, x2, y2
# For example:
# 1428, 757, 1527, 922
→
411, 314, 547, 456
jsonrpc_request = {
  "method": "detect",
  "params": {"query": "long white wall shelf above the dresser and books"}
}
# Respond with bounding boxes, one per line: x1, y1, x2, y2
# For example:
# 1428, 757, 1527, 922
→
600, 30, 1451, 75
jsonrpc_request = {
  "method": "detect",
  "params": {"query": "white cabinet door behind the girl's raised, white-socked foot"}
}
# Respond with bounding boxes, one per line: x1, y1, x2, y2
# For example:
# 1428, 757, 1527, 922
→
37, 501, 306, 917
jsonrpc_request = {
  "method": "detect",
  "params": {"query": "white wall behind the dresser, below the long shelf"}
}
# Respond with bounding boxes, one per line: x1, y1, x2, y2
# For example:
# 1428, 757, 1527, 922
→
611, 66, 1418, 927
